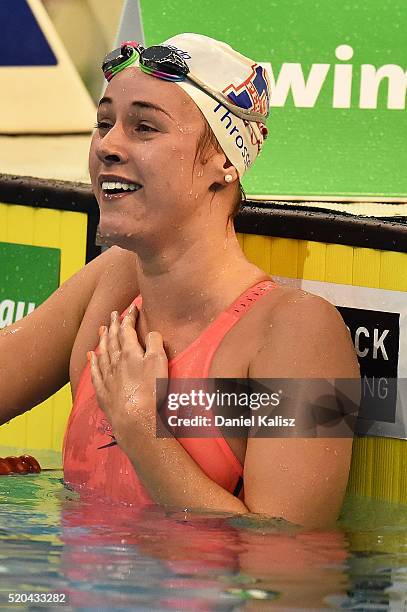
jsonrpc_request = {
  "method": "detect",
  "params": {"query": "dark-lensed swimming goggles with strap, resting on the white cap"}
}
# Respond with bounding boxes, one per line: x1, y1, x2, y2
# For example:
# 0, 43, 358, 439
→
102, 41, 268, 123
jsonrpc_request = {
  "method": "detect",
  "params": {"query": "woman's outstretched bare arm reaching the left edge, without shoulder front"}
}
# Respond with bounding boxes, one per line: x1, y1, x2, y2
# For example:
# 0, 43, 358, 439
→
0, 247, 134, 423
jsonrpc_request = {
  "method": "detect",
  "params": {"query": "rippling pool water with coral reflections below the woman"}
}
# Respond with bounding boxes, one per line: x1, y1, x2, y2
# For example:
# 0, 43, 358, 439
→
0, 471, 407, 611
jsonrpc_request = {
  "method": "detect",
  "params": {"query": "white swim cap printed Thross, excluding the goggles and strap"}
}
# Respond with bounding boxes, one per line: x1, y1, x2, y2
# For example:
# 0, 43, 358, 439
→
161, 34, 270, 177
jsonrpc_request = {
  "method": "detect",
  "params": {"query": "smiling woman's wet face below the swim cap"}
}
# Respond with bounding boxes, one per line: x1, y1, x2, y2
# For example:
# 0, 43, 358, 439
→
89, 68, 218, 248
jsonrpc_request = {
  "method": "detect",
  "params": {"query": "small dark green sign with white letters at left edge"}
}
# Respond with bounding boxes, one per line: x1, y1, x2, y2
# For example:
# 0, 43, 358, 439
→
0, 242, 61, 329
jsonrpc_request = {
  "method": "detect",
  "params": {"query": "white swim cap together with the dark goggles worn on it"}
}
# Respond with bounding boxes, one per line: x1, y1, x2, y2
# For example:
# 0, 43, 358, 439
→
102, 34, 270, 177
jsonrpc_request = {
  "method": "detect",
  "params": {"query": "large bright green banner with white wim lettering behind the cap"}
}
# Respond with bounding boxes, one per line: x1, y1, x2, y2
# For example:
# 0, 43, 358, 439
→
141, 0, 407, 199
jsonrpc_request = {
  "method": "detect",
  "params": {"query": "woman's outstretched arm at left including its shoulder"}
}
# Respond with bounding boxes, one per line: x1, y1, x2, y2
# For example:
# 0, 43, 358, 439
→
0, 248, 137, 422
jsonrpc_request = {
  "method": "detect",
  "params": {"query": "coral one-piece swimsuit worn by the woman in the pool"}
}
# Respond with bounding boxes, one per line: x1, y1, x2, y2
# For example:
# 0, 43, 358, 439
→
63, 280, 276, 505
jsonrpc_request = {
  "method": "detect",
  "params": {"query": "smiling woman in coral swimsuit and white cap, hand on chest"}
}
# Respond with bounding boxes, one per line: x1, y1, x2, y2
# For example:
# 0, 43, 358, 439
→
0, 34, 358, 526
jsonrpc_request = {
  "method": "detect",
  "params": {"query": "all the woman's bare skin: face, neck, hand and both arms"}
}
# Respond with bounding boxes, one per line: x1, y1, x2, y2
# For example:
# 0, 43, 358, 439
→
0, 68, 358, 526
